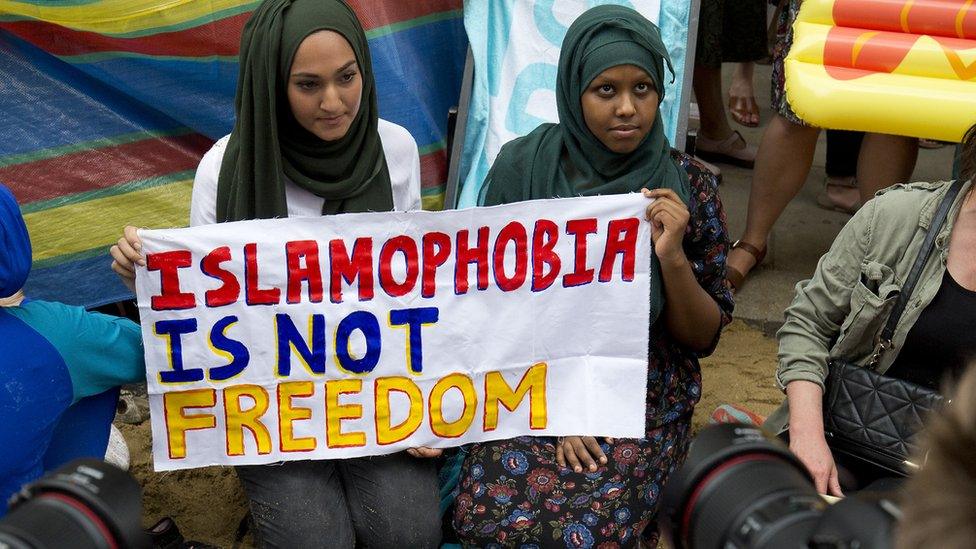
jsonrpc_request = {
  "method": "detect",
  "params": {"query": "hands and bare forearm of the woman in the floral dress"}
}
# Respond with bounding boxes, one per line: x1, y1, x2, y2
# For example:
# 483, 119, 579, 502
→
556, 189, 722, 473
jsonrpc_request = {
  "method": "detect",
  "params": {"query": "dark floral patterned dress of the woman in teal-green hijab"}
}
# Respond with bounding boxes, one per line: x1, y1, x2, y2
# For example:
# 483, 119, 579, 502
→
454, 151, 732, 549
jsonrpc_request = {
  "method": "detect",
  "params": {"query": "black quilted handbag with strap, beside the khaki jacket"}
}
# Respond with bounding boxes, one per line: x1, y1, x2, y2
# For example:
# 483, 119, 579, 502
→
823, 181, 962, 476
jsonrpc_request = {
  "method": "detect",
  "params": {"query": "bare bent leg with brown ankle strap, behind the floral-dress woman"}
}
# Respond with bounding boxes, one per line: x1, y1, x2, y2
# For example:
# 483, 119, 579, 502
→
728, 114, 820, 274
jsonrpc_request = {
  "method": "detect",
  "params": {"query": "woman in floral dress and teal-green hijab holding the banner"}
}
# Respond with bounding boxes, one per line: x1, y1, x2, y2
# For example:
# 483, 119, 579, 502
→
454, 6, 732, 547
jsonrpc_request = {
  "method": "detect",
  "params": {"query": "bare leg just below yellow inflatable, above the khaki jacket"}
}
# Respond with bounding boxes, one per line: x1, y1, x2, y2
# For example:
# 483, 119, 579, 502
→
857, 133, 918, 202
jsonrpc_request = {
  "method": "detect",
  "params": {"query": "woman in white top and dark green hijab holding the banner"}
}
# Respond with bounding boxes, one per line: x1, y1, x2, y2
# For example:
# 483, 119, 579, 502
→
112, 0, 441, 547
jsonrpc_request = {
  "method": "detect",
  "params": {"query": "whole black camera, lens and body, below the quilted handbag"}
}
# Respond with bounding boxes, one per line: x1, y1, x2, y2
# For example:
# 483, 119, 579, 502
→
659, 424, 900, 549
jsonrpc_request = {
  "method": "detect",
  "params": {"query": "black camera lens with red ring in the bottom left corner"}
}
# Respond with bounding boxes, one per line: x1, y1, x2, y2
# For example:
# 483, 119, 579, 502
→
0, 459, 149, 549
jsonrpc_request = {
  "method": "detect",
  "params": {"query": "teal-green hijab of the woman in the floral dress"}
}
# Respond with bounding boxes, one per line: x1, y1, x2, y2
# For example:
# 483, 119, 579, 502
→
479, 5, 691, 324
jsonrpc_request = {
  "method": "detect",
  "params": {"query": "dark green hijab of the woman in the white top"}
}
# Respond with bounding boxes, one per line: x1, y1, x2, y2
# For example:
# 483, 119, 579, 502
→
217, 0, 393, 221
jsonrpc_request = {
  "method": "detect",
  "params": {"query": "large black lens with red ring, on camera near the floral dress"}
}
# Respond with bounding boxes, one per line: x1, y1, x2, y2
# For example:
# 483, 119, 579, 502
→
660, 424, 826, 549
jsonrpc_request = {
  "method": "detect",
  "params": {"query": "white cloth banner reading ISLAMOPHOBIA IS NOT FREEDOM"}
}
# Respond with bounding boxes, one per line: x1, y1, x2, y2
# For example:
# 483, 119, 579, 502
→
136, 194, 652, 470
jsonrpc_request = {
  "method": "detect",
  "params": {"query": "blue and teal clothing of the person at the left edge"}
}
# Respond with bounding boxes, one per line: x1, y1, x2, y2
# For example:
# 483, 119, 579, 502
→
0, 301, 146, 510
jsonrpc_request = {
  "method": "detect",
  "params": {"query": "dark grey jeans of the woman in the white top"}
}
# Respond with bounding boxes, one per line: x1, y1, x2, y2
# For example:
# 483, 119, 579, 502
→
237, 452, 441, 549
